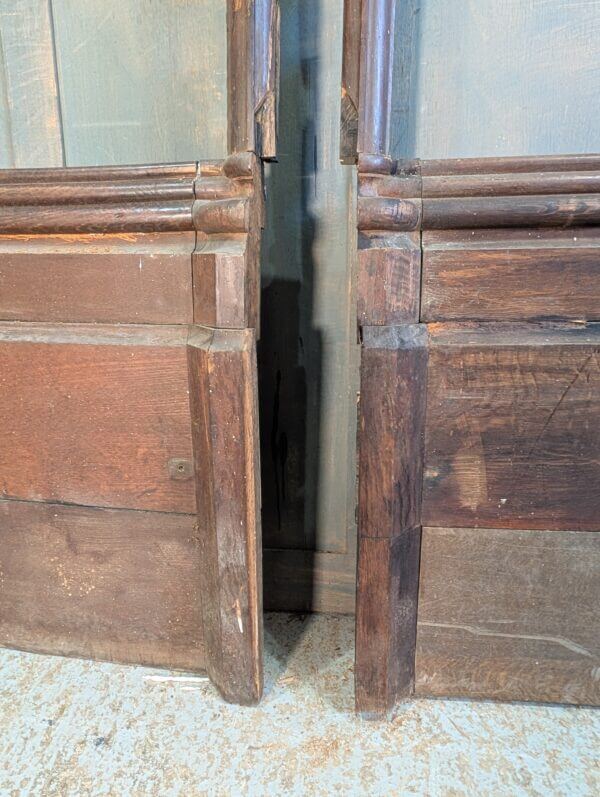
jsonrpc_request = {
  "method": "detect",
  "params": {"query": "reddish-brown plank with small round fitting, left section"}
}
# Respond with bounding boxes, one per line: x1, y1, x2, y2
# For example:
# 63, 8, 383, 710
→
0, 323, 196, 512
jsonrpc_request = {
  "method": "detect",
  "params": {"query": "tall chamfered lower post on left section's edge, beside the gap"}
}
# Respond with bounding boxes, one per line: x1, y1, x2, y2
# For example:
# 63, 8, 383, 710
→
188, 327, 263, 704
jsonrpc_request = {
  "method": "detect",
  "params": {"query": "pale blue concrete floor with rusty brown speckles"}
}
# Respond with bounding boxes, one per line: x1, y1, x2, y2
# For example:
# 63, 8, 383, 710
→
0, 614, 600, 797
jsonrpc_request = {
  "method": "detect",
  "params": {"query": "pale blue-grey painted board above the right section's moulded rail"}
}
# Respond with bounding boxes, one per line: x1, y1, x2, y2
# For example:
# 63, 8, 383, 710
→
391, 0, 600, 158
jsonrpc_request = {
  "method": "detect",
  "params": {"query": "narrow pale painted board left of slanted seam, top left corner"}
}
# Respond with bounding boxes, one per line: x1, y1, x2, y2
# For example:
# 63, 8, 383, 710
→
0, 0, 63, 168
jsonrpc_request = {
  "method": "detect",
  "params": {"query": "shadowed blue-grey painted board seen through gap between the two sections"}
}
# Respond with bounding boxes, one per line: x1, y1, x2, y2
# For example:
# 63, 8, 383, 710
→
259, 0, 357, 560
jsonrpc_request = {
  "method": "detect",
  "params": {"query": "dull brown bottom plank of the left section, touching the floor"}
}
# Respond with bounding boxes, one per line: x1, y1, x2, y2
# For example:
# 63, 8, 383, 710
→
0, 501, 205, 671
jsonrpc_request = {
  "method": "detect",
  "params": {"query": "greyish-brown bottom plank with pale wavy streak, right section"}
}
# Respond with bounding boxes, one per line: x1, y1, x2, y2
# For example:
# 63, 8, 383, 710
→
415, 528, 600, 705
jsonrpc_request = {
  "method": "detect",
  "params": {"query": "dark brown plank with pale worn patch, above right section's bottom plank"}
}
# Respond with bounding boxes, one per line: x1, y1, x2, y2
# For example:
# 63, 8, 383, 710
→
423, 323, 600, 530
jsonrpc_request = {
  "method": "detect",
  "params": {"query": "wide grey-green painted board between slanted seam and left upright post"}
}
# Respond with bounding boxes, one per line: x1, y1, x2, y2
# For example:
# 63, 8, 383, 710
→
52, 0, 227, 166
